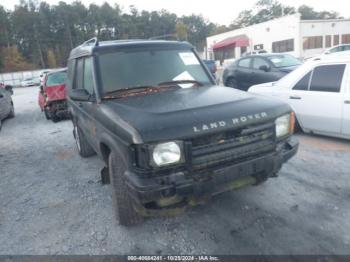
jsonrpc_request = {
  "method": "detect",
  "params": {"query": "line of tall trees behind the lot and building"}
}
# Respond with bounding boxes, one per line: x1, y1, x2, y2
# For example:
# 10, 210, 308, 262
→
0, 0, 339, 72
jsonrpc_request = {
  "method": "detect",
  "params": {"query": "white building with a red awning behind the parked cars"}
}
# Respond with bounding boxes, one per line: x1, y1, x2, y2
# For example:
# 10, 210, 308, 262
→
206, 14, 350, 61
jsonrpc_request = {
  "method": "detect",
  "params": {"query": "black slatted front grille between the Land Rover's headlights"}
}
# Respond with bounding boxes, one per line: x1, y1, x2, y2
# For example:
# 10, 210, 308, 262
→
192, 123, 276, 169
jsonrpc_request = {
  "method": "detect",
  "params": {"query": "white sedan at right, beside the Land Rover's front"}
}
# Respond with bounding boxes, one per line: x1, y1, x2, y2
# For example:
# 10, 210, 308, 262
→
249, 56, 350, 139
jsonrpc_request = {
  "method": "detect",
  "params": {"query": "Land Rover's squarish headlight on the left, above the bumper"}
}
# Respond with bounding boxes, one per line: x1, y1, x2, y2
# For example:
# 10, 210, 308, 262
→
152, 142, 182, 167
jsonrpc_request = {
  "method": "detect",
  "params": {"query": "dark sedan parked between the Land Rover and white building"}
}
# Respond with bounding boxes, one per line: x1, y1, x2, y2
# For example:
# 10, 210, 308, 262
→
223, 54, 301, 91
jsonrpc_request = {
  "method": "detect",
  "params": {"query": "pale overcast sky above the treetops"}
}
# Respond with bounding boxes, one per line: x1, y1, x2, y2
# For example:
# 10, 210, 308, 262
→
0, 0, 350, 25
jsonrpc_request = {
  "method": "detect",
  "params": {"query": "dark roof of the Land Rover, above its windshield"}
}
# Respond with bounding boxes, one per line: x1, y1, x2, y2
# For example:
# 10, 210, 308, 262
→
69, 38, 193, 59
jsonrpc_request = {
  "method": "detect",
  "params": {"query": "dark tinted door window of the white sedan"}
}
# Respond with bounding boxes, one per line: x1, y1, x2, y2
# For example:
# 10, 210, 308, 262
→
310, 65, 345, 92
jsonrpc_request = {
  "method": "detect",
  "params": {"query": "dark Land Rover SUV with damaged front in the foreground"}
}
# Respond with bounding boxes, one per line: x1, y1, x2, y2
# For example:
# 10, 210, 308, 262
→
67, 39, 298, 225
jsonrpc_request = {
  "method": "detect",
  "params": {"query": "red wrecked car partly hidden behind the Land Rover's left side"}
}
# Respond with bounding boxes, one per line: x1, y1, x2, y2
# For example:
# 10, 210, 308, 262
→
38, 69, 69, 122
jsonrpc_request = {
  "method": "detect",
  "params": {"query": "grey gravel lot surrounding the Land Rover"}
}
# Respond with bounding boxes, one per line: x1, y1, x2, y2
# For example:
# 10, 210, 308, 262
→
0, 88, 350, 254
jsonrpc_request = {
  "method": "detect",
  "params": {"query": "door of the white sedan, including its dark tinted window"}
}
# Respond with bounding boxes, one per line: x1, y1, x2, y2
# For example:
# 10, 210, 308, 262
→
289, 64, 345, 134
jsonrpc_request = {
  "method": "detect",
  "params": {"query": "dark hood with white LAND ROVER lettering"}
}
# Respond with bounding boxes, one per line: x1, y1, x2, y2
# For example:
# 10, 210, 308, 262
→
101, 86, 291, 143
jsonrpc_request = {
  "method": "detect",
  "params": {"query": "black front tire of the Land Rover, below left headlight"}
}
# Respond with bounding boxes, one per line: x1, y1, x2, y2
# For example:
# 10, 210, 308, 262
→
108, 152, 143, 226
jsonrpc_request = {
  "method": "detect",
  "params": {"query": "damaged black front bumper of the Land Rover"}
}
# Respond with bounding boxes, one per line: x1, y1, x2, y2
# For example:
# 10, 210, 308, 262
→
125, 137, 299, 216
